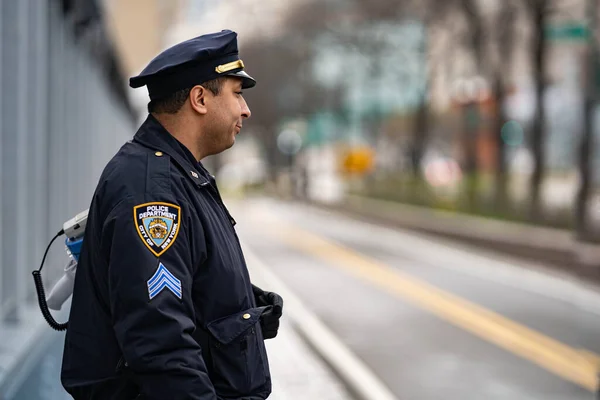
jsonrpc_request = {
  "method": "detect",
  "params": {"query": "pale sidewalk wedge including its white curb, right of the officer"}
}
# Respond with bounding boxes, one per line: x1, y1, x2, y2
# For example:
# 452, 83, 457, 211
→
242, 243, 397, 400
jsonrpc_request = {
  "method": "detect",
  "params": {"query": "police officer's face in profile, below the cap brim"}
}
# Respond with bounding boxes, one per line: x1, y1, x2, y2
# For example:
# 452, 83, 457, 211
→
207, 77, 251, 154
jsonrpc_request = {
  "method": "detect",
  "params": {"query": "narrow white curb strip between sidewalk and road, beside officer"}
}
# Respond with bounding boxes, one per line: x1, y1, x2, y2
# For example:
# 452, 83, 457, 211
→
242, 245, 398, 400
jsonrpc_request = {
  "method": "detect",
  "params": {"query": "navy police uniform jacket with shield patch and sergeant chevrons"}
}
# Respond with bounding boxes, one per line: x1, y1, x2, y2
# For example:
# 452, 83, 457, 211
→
61, 116, 271, 400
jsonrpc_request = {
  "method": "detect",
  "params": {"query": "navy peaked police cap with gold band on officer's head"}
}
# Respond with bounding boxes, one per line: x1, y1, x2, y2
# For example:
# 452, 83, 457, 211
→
129, 30, 256, 100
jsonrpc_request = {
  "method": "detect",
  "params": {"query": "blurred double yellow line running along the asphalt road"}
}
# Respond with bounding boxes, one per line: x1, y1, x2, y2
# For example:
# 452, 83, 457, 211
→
263, 219, 600, 391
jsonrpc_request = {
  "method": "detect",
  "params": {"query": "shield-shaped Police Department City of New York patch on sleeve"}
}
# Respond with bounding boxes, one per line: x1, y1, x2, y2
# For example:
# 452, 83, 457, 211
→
133, 202, 181, 257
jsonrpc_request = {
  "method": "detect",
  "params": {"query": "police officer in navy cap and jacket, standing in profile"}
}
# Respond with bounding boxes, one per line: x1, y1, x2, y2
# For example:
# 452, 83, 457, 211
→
61, 31, 283, 400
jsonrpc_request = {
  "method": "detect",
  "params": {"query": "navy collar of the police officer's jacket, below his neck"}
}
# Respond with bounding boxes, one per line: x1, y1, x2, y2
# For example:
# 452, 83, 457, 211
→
133, 114, 210, 186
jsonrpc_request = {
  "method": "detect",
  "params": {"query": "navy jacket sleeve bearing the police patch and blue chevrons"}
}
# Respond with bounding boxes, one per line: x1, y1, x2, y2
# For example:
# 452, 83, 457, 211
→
102, 195, 217, 400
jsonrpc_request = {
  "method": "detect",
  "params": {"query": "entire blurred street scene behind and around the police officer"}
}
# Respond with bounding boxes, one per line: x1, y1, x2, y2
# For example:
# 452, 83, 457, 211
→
0, 0, 600, 400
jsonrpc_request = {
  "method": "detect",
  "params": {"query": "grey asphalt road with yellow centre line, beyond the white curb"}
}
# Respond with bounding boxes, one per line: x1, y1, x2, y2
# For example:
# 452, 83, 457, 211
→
227, 198, 600, 400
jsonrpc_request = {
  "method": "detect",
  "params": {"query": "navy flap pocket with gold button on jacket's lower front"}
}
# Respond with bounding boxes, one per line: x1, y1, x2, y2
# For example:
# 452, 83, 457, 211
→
207, 307, 269, 397
